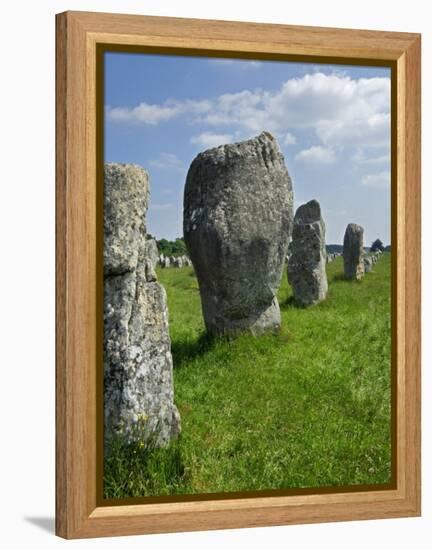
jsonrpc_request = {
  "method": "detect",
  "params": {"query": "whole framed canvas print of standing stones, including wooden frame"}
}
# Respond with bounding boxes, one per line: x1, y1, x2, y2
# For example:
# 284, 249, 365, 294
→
56, 12, 420, 538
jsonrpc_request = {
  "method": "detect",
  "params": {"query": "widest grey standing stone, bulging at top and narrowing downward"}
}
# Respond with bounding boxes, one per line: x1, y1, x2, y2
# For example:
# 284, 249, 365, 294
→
183, 132, 293, 335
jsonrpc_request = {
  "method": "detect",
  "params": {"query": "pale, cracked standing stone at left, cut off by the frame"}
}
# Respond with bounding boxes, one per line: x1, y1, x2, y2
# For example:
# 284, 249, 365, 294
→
104, 163, 180, 445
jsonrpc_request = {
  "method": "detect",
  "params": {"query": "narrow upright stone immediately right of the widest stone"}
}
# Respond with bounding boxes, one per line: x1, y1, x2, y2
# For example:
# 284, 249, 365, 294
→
288, 200, 328, 306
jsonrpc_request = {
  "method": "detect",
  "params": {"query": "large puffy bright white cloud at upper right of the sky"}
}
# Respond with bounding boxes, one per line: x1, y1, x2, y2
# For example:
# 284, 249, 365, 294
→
201, 73, 390, 150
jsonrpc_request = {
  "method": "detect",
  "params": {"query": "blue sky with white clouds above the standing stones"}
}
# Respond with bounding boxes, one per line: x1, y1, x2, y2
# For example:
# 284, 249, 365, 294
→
105, 53, 390, 245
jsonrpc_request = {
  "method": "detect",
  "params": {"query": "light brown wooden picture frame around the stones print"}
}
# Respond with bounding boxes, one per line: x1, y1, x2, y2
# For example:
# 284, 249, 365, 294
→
56, 12, 420, 538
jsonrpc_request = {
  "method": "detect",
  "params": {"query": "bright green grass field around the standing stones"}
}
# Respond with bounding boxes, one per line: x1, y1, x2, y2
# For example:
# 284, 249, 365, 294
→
105, 253, 391, 498
